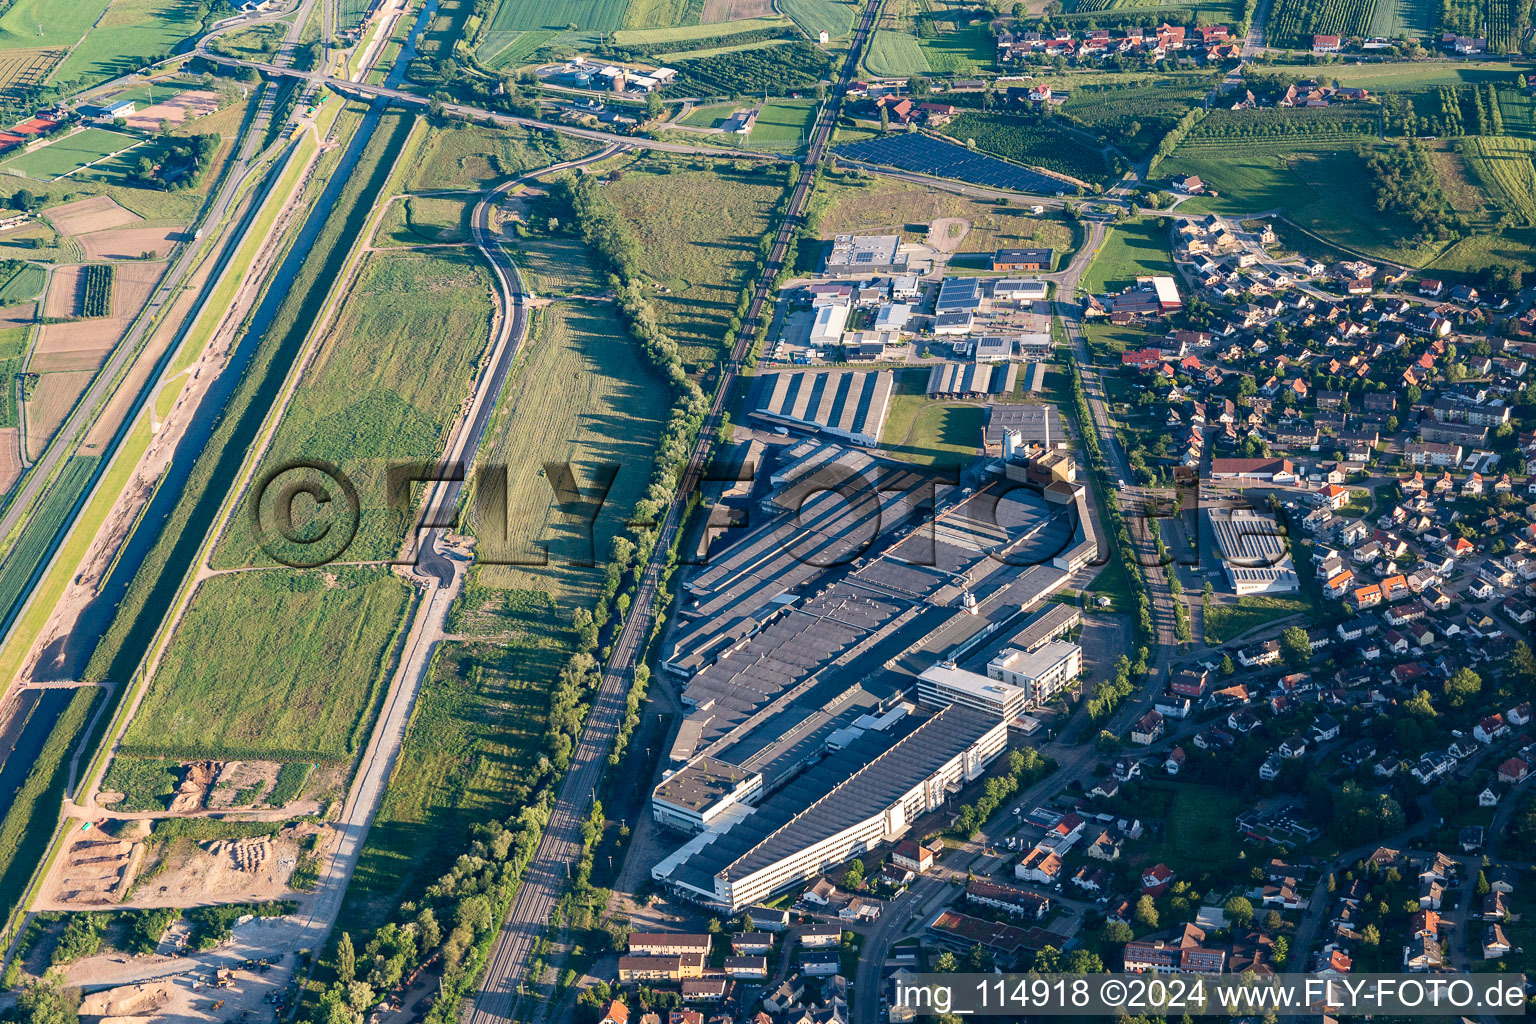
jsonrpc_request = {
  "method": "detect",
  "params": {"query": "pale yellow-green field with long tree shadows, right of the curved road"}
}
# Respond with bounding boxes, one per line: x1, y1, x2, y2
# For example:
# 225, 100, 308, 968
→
472, 251, 670, 601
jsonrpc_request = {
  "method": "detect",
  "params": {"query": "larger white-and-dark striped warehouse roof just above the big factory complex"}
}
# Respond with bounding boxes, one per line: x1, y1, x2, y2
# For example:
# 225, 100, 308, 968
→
748, 370, 895, 444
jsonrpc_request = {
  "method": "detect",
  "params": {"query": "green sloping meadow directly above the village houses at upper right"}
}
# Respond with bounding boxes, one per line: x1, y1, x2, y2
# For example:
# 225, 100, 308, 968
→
1158, 141, 1444, 266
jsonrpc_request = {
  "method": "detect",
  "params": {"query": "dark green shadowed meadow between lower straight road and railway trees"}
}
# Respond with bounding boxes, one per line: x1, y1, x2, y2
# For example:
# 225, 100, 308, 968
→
341, 620, 570, 927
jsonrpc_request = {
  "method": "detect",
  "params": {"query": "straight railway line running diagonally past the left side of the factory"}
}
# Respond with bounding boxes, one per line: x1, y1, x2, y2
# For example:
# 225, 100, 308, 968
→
467, 0, 880, 1024
